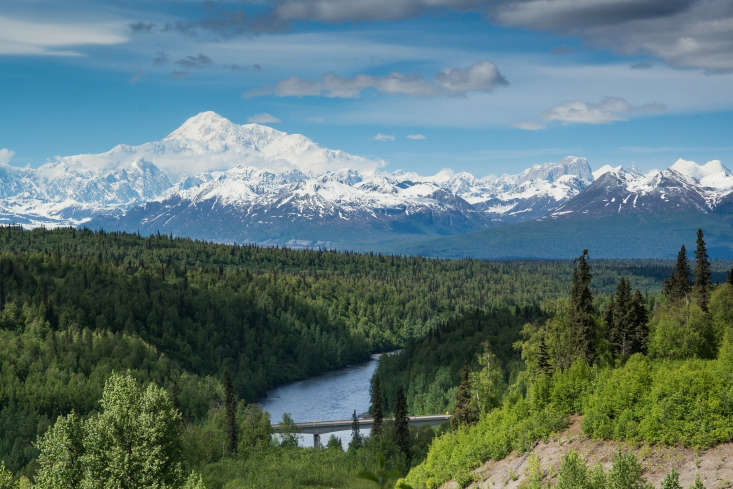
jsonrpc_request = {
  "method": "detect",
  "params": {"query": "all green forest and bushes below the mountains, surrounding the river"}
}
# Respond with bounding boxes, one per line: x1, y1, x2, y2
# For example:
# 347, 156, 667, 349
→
0, 227, 733, 489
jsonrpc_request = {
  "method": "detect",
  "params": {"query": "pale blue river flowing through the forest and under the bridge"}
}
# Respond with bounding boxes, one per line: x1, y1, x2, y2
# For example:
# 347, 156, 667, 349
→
260, 355, 379, 447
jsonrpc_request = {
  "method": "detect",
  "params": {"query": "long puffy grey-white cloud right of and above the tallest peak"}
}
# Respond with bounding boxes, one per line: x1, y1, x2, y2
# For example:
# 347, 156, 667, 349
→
245, 61, 507, 98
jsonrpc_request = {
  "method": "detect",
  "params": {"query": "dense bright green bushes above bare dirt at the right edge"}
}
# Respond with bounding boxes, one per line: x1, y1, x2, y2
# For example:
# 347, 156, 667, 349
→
582, 355, 733, 447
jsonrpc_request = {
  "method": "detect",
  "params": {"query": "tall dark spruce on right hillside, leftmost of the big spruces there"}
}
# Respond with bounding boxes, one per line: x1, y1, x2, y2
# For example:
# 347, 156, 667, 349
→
569, 250, 595, 363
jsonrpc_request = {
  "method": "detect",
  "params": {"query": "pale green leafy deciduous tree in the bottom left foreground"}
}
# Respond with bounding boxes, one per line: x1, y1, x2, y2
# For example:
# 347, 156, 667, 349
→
36, 374, 203, 489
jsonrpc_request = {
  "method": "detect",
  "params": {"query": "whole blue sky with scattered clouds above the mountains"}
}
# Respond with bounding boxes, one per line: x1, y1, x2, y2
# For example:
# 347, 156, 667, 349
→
0, 0, 733, 175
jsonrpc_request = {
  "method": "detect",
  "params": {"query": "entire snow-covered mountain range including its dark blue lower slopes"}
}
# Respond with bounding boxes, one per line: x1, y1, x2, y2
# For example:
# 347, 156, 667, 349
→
0, 112, 733, 259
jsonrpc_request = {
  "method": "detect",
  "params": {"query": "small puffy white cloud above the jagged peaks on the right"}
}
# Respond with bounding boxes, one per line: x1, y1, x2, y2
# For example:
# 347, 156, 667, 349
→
543, 97, 665, 124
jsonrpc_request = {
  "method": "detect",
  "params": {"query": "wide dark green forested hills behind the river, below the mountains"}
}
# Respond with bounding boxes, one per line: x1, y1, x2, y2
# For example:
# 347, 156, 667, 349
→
0, 227, 722, 469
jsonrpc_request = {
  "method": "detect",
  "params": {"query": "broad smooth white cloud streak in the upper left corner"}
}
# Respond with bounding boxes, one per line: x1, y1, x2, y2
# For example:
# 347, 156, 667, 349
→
0, 16, 128, 56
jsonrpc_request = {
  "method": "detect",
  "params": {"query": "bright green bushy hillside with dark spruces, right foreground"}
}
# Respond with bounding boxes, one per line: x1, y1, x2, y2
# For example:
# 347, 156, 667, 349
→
400, 234, 733, 489
